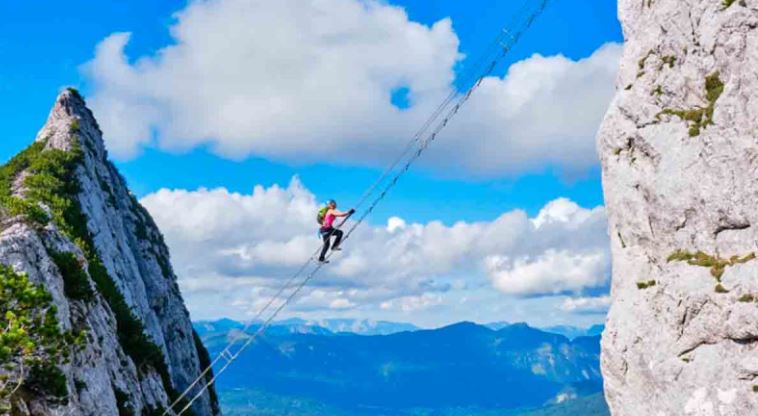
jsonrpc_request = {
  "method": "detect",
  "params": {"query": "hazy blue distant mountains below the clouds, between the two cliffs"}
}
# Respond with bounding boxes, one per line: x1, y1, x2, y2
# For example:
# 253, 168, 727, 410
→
195, 320, 602, 416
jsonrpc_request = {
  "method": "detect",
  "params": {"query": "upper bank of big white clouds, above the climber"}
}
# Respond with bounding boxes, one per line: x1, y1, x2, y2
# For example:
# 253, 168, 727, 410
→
84, 0, 621, 175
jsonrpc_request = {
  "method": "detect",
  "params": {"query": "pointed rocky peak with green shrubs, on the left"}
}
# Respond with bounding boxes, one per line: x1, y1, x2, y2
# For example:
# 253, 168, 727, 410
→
0, 89, 219, 416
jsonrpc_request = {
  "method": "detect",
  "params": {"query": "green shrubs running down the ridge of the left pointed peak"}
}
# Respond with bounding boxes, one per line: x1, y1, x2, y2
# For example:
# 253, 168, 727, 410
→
0, 124, 191, 414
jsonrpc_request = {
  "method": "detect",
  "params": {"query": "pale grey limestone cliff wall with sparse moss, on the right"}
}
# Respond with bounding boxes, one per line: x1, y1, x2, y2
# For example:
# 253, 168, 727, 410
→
598, 0, 758, 416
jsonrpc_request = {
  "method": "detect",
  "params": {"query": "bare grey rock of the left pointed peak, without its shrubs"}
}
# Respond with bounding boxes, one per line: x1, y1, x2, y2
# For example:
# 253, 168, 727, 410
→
0, 90, 218, 416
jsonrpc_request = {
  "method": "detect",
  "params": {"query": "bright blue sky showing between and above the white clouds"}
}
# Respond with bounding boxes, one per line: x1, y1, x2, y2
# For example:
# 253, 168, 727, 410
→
0, 0, 622, 323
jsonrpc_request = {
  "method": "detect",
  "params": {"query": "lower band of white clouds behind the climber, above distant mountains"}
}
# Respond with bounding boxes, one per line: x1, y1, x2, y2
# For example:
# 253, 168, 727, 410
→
141, 178, 609, 322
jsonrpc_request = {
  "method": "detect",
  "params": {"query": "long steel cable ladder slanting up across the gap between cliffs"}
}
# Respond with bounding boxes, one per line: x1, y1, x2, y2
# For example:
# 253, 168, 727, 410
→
162, 0, 550, 416
